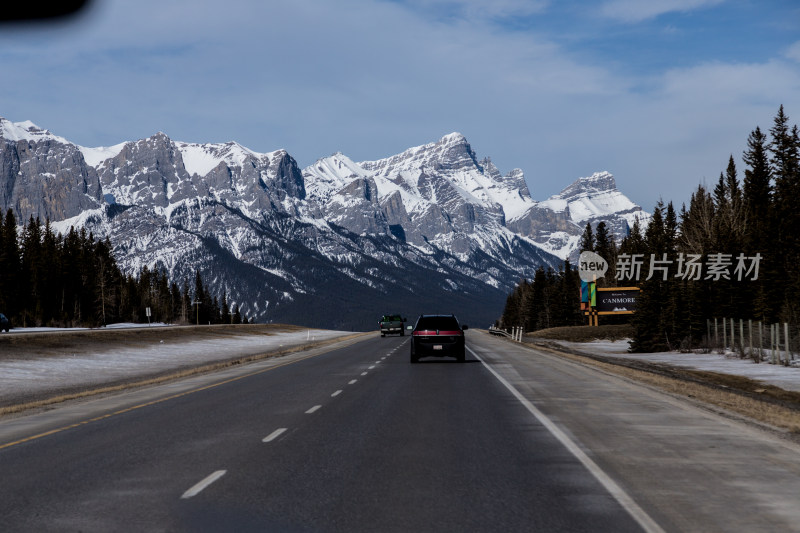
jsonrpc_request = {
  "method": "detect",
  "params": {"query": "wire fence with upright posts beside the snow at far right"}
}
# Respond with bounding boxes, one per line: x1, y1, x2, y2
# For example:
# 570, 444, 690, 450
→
705, 318, 800, 366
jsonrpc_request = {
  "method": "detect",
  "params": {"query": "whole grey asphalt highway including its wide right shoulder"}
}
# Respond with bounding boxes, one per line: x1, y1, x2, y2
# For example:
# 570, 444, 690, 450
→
0, 331, 800, 532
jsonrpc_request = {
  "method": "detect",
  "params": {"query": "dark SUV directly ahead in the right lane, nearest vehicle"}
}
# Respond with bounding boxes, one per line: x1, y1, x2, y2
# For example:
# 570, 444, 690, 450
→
411, 315, 469, 363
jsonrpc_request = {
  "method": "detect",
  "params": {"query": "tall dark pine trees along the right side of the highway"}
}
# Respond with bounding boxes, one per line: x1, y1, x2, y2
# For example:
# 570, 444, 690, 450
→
502, 106, 800, 352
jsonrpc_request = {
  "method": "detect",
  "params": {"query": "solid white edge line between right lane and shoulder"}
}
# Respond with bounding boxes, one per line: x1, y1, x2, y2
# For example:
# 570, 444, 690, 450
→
467, 346, 664, 533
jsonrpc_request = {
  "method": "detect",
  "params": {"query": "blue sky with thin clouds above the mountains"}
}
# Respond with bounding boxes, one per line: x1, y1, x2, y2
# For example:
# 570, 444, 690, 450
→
0, 0, 800, 210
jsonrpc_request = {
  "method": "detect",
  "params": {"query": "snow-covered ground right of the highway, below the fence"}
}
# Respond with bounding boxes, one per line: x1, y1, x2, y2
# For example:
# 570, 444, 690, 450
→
553, 340, 800, 391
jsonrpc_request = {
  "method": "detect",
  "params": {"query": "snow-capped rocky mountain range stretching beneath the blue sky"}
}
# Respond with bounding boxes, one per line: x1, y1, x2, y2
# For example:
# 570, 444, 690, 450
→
0, 118, 643, 329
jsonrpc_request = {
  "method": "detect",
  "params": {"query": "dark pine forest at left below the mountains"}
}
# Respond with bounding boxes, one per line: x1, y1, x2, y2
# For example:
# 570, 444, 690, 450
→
0, 209, 247, 327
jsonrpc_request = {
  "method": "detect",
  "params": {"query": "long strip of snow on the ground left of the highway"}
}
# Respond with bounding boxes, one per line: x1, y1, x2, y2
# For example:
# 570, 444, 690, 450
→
0, 325, 352, 401
